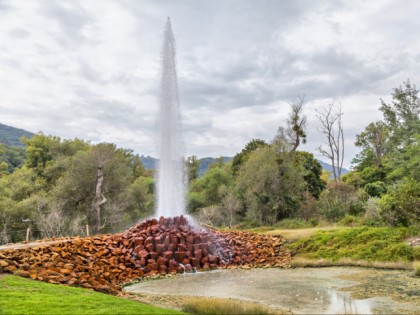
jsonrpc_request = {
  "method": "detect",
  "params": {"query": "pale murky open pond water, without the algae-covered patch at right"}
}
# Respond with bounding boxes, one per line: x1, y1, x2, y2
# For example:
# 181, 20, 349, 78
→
126, 268, 414, 314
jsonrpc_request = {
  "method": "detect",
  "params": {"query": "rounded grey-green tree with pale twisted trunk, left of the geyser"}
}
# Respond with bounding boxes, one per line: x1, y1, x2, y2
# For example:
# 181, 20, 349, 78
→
52, 143, 133, 233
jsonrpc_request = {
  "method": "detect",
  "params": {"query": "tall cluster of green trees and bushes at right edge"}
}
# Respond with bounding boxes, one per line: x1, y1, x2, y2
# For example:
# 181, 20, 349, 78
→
352, 81, 420, 230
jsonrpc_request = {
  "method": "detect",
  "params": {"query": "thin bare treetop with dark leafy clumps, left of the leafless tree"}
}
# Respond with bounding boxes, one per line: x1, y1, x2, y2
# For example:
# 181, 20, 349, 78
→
286, 95, 306, 152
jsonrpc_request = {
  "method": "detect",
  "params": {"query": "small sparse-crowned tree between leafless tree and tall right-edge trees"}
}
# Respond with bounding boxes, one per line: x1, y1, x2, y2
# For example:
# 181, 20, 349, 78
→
355, 121, 389, 167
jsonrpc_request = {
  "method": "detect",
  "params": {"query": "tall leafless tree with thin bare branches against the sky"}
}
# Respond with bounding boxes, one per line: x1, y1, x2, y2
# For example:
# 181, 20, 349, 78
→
316, 101, 344, 182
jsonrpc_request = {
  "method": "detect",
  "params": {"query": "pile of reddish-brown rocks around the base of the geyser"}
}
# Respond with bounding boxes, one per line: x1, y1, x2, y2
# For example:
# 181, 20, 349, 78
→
0, 216, 290, 293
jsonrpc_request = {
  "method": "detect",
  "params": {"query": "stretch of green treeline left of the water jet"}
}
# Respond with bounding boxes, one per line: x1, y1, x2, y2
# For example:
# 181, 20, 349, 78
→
0, 137, 154, 243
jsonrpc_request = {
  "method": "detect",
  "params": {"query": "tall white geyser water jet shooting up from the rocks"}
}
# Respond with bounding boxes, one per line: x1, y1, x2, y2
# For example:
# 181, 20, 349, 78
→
156, 17, 185, 217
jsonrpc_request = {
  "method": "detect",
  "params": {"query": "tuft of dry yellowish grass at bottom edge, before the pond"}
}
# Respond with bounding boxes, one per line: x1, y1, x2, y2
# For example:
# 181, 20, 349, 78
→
182, 297, 291, 315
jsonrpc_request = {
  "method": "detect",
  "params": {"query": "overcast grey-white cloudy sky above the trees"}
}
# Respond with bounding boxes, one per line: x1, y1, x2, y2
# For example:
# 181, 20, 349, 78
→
0, 0, 420, 167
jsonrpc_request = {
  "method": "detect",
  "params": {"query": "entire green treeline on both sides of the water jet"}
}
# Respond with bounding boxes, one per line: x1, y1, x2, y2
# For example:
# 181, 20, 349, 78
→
0, 82, 420, 243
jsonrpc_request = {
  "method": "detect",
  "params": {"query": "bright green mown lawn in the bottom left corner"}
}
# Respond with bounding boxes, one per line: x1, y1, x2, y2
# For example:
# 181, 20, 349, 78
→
0, 275, 183, 315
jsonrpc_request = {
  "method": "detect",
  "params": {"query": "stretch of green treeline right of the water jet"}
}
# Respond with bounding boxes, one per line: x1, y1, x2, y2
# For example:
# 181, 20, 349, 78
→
187, 81, 420, 227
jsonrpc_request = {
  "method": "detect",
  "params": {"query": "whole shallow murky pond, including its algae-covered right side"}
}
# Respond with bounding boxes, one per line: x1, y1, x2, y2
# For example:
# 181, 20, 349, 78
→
125, 267, 420, 314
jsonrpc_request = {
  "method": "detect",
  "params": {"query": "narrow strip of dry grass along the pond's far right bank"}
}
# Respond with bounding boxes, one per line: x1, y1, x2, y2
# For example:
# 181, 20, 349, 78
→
290, 257, 412, 273
